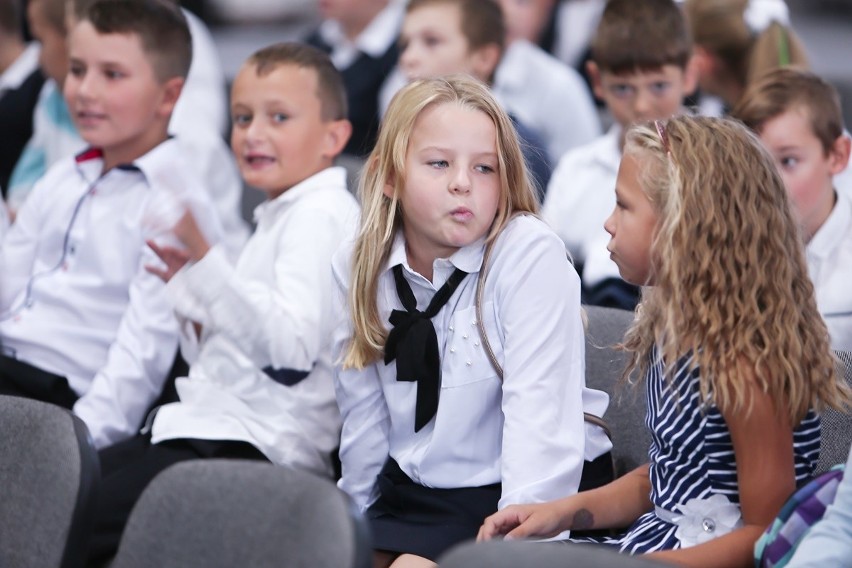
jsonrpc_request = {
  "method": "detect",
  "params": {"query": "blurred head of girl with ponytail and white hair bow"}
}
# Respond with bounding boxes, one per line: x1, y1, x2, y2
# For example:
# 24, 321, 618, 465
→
683, 0, 808, 108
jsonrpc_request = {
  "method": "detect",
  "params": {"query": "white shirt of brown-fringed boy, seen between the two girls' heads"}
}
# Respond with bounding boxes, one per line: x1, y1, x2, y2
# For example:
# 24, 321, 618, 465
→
541, 125, 621, 263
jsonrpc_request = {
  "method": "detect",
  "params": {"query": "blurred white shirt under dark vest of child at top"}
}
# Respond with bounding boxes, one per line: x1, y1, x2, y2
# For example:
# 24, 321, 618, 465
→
318, 0, 405, 70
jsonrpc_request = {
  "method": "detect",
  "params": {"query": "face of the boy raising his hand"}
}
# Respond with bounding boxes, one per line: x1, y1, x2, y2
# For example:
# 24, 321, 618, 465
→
231, 64, 350, 199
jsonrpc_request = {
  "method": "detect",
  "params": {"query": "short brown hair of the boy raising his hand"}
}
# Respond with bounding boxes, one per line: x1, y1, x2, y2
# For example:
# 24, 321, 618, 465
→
246, 42, 349, 120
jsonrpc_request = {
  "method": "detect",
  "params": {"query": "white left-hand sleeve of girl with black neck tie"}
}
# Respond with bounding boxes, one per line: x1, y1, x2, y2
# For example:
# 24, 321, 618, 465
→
332, 246, 390, 512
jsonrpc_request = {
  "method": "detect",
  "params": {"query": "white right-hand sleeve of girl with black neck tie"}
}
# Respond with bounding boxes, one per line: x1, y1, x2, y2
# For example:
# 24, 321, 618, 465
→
487, 221, 585, 508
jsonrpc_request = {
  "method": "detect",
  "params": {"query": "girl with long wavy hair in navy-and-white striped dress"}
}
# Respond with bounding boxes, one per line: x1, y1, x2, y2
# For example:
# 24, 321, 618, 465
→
480, 113, 848, 566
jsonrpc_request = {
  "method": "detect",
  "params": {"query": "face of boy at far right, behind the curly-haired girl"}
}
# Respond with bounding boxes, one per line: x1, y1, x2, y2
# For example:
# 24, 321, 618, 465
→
760, 106, 849, 238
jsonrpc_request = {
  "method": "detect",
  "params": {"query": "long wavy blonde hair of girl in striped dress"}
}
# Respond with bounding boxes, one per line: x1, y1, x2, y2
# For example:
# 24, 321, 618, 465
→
624, 116, 848, 424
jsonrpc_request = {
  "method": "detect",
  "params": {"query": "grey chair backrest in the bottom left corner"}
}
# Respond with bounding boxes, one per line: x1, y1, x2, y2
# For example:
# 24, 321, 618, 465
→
0, 395, 100, 568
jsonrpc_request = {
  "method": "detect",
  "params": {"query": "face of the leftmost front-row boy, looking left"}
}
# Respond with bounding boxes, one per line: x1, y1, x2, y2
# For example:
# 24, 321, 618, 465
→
65, 21, 183, 168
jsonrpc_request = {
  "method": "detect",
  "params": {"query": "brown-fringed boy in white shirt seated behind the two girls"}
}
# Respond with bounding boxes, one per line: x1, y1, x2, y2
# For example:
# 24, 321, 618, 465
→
542, 0, 695, 309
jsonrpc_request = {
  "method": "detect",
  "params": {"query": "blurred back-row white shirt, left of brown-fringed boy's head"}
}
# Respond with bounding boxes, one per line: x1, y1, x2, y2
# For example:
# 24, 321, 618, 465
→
493, 40, 601, 161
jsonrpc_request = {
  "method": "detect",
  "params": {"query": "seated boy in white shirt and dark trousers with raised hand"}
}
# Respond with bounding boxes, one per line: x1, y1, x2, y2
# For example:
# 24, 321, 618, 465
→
90, 43, 358, 563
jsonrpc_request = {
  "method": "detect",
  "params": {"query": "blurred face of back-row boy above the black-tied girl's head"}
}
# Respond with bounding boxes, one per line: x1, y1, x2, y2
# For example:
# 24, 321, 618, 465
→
399, 3, 499, 81
